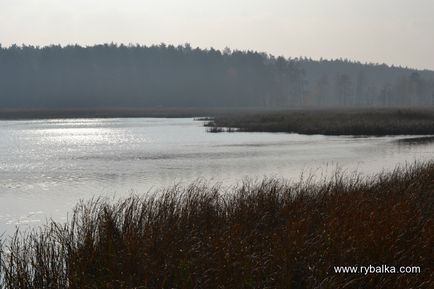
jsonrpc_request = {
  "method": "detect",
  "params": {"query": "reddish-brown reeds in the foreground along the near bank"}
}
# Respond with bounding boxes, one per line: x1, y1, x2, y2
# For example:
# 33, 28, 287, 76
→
0, 163, 434, 289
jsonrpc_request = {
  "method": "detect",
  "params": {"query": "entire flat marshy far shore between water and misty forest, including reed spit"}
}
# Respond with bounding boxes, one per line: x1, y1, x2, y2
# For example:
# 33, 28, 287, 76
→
0, 107, 434, 136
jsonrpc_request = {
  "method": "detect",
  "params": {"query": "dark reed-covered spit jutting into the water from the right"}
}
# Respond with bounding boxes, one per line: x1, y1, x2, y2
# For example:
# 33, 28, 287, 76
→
205, 109, 434, 136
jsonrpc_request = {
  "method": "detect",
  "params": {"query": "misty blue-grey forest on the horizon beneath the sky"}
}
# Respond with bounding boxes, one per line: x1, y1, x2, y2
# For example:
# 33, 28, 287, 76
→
0, 44, 434, 109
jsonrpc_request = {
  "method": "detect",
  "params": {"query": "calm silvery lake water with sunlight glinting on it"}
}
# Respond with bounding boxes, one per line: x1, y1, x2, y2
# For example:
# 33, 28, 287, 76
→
0, 118, 434, 232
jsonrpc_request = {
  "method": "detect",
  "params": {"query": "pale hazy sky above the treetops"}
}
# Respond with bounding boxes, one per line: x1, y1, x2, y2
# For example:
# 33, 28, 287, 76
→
0, 0, 434, 69
